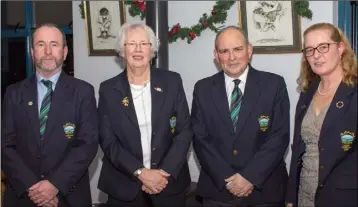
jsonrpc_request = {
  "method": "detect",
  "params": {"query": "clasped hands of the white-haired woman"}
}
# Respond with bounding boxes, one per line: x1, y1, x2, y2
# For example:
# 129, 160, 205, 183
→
138, 168, 170, 195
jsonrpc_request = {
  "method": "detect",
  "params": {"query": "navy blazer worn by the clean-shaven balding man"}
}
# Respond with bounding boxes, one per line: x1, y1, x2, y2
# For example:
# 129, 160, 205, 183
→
191, 66, 290, 204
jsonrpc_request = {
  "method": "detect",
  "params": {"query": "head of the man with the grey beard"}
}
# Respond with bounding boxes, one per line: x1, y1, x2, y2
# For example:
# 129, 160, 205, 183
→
31, 26, 68, 76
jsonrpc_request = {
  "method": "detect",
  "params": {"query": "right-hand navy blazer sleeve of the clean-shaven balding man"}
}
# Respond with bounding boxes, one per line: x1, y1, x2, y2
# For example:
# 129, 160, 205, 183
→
239, 78, 290, 188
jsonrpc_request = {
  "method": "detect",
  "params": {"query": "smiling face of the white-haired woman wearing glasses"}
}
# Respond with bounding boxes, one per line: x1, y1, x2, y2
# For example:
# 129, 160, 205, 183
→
123, 28, 152, 68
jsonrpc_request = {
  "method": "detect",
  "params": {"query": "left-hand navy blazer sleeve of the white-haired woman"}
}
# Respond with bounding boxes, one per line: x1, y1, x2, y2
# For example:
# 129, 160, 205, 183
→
98, 84, 144, 179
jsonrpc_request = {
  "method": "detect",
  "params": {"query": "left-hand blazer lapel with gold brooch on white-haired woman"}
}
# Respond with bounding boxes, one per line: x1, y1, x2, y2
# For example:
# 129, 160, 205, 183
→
113, 70, 139, 130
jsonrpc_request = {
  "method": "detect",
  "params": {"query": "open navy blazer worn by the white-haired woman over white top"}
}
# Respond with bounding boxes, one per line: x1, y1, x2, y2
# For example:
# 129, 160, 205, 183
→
98, 68, 193, 201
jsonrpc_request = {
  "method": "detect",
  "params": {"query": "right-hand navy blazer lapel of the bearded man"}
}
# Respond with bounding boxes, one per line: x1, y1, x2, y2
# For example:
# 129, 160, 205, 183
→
43, 71, 73, 142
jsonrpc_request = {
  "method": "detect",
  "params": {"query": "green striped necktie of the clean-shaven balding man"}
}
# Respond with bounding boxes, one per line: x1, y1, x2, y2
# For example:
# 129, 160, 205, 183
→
230, 79, 242, 133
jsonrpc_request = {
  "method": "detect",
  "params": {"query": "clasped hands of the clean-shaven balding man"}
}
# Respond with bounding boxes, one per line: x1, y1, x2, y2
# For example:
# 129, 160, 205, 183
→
225, 173, 254, 197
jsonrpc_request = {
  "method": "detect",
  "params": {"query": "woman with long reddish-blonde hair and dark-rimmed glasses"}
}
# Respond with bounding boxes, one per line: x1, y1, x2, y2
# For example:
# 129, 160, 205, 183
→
286, 23, 358, 207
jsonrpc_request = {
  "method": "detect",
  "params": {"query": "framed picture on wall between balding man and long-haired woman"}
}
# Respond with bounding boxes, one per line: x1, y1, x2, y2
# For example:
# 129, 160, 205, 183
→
238, 1, 302, 54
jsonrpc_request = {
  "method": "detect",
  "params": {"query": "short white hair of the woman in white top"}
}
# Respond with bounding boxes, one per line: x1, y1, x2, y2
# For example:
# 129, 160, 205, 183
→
114, 23, 160, 58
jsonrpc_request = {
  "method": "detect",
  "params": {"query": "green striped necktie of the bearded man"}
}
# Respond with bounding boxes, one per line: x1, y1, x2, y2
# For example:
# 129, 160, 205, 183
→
39, 80, 52, 137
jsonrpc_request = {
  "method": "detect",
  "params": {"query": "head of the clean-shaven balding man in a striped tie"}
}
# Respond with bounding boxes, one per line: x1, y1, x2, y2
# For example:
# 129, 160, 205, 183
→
214, 28, 252, 78
